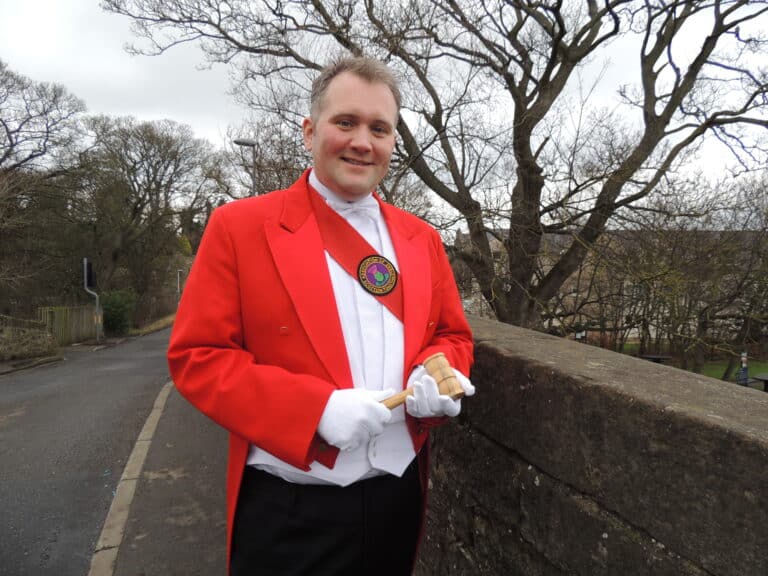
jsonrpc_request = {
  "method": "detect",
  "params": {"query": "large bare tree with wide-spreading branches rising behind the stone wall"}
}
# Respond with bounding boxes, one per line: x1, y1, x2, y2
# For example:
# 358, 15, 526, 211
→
102, 0, 768, 326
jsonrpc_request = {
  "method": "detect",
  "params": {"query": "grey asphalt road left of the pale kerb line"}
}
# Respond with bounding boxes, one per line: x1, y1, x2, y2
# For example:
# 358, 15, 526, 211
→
0, 330, 169, 576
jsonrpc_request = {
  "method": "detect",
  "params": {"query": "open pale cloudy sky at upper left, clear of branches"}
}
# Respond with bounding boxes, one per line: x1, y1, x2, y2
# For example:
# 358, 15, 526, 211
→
0, 0, 247, 146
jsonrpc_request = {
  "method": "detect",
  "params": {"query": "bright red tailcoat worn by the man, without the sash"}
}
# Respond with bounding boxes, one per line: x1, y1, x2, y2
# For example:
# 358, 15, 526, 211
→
168, 171, 472, 558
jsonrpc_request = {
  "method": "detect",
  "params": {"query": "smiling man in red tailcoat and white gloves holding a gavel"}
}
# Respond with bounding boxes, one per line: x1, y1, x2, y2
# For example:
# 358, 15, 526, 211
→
168, 58, 474, 576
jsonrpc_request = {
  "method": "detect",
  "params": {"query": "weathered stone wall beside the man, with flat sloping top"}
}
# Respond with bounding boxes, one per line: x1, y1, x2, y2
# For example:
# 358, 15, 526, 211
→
417, 319, 768, 576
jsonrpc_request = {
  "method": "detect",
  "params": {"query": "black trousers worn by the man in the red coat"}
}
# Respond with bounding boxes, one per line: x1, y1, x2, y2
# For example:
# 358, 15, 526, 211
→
230, 460, 421, 576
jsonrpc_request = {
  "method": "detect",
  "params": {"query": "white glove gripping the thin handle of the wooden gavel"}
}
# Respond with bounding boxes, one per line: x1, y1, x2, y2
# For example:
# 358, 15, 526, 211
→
317, 388, 394, 450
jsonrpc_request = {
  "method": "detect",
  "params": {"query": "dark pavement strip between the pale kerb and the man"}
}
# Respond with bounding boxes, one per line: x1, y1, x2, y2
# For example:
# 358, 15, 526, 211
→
108, 386, 228, 576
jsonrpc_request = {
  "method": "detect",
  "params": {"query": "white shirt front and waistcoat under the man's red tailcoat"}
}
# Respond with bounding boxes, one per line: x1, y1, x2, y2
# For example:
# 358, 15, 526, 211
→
247, 171, 415, 486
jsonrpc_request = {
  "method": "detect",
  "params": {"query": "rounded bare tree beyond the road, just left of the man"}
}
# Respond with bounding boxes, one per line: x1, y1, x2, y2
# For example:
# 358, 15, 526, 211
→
69, 116, 226, 294
